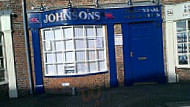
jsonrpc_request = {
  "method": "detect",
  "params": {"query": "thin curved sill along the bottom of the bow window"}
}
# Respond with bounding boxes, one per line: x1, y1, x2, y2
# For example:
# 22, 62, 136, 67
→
45, 71, 108, 78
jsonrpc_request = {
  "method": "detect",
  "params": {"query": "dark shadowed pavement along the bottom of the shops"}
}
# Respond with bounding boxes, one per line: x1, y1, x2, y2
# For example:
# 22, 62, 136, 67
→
0, 83, 190, 107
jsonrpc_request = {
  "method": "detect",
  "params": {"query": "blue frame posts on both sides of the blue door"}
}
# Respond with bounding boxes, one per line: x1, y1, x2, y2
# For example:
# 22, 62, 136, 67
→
121, 21, 166, 86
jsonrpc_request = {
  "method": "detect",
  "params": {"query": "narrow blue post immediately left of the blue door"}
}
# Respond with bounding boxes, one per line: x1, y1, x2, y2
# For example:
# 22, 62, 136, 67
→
121, 23, 133, 86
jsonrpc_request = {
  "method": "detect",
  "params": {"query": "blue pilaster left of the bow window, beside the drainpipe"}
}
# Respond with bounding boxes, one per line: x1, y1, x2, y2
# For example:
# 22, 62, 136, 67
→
32, 29, 44, 94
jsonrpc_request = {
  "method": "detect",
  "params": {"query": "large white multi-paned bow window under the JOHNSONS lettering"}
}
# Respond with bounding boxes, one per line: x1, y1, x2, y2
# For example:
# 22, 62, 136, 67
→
42, 25, 107, 76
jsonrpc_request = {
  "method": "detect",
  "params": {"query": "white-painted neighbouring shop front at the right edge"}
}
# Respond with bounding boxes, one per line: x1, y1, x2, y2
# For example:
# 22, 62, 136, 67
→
165, 2, 190, 82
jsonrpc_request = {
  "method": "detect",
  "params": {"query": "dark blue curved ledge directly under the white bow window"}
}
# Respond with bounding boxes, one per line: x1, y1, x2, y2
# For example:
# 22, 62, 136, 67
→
45, 71, 109, 78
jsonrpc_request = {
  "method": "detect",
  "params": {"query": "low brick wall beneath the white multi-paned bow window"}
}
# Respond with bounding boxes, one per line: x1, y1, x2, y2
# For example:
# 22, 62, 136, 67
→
44, 73, 109, 93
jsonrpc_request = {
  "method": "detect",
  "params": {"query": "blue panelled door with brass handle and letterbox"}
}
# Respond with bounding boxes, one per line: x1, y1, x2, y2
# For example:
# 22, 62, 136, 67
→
127, 22, 162, 83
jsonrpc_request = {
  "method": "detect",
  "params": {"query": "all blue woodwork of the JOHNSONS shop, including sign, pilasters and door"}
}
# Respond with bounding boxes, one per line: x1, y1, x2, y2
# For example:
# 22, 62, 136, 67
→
27, 5, 165, 93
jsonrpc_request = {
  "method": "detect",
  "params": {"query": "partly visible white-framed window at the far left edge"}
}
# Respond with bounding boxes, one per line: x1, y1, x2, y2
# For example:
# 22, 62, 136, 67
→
0, 33, 7, 84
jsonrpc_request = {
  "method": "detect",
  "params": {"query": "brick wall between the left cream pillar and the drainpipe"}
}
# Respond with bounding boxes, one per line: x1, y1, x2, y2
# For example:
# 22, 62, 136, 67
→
0, 0, 29, 96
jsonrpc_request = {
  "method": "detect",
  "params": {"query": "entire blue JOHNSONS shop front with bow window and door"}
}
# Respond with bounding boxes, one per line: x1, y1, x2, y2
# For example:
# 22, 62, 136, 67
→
28, 4, 165, 93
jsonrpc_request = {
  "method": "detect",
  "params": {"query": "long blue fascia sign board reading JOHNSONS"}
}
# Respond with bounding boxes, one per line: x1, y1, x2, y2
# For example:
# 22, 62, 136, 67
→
27, 5, 161, 28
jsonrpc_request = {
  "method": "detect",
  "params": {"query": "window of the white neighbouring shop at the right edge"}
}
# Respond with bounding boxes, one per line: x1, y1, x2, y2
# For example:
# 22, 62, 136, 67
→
176, 20, 190, 67
